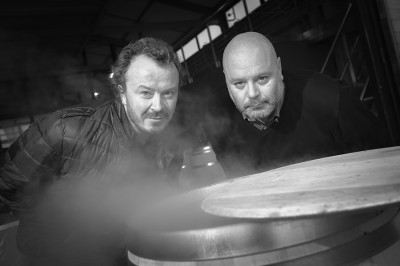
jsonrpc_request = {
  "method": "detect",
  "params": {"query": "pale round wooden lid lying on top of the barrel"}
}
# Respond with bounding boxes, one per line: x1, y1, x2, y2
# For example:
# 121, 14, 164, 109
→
201, 146, 400, 218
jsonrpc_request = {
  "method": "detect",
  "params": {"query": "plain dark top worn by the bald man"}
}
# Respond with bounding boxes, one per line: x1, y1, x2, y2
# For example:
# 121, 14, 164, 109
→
220, 71, 389, 177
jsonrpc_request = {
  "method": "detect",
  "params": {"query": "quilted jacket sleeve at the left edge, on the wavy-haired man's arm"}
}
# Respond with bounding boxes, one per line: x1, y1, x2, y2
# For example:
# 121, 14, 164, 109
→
0, 113, 62, 215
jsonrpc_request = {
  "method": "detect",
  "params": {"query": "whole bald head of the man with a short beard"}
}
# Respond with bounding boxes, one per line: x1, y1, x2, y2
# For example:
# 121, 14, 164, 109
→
223, 32, 285, 130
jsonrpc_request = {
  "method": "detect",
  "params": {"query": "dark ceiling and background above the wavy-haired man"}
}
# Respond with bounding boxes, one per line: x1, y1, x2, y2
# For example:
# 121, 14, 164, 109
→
0, 0, 237, 121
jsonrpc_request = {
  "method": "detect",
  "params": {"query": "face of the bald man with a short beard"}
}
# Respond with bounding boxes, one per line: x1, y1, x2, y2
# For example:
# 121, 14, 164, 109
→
224, 47, 284, 121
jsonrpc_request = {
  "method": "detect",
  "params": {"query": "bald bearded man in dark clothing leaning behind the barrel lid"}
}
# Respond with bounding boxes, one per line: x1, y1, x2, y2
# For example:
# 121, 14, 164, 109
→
220, 32, 388, 176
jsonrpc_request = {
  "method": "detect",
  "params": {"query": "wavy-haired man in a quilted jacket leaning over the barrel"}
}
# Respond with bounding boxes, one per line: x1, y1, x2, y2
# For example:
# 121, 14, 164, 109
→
0, 38, 182, 266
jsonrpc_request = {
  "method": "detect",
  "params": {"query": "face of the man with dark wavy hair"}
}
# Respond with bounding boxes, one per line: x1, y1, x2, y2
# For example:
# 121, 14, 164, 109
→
121, 55, 179, 134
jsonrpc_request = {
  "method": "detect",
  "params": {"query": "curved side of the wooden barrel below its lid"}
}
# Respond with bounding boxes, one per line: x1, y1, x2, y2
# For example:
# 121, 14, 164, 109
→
128, 207, 400, 266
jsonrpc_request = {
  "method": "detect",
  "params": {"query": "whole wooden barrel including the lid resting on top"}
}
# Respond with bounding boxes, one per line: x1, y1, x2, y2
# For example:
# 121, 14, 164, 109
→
128, 147, 400, 266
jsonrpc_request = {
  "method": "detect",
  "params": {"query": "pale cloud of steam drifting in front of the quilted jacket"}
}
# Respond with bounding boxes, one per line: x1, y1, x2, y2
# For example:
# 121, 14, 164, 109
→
28, 153, 183, 259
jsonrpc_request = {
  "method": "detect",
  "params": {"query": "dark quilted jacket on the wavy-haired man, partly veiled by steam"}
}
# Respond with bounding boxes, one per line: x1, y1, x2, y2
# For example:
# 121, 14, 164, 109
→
0, 100, 180, 265
